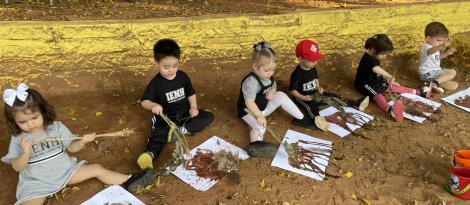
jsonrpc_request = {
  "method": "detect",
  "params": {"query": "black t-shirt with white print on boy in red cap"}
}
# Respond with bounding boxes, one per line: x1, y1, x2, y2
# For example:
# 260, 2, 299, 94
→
289, 65, 318, 95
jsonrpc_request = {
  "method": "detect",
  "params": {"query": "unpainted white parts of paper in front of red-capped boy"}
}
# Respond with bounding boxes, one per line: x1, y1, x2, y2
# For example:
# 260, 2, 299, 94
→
320, 106, 374, 137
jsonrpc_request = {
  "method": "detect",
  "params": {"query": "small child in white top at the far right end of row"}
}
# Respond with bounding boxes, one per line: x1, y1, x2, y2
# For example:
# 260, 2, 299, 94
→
418, 22, 459, 93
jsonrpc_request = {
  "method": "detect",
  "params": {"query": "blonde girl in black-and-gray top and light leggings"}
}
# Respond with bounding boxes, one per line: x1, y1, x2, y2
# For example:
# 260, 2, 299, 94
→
237, 42, 328, 157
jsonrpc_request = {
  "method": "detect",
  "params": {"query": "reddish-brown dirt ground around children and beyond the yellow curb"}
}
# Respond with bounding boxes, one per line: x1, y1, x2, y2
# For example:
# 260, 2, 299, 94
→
0, 0, 470, 205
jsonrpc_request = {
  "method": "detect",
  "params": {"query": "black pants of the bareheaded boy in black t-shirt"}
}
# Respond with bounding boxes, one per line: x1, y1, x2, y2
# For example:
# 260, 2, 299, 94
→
145, 110, 214, 159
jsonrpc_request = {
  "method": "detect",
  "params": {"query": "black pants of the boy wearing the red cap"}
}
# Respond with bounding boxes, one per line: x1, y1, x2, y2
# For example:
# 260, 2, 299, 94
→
294, 92, 353, 121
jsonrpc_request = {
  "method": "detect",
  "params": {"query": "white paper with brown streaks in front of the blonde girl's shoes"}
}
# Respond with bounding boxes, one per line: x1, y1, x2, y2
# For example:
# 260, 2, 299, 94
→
271, 130, 332, 181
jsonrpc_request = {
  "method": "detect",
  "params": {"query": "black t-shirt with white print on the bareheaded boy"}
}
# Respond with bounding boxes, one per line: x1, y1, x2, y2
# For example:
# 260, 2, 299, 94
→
141, 70, 195, 114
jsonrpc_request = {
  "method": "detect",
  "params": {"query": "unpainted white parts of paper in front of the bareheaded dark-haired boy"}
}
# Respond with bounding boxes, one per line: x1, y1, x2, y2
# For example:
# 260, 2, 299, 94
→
167, 136, 249, 191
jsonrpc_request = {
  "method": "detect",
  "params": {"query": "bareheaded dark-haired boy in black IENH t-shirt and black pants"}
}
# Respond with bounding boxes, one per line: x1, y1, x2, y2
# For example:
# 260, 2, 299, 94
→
137, 39, 214, 169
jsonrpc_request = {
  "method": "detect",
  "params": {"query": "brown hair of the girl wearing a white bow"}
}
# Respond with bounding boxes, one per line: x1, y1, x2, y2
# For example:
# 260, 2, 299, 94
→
5, 88, 55, 135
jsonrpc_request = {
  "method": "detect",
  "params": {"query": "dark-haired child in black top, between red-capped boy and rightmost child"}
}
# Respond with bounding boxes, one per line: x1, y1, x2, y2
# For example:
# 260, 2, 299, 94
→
354, 34, 431, 122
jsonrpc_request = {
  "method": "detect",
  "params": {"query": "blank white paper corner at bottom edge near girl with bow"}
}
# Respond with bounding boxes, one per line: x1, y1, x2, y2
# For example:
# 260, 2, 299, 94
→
81, 185, 145, 205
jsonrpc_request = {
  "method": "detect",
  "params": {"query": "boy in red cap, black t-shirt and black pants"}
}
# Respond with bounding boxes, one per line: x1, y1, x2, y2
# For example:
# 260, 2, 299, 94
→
289, 40, 369, 124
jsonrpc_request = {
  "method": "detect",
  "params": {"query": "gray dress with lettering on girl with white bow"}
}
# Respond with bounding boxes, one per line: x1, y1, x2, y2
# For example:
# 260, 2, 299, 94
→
1, 121, 86, 205
